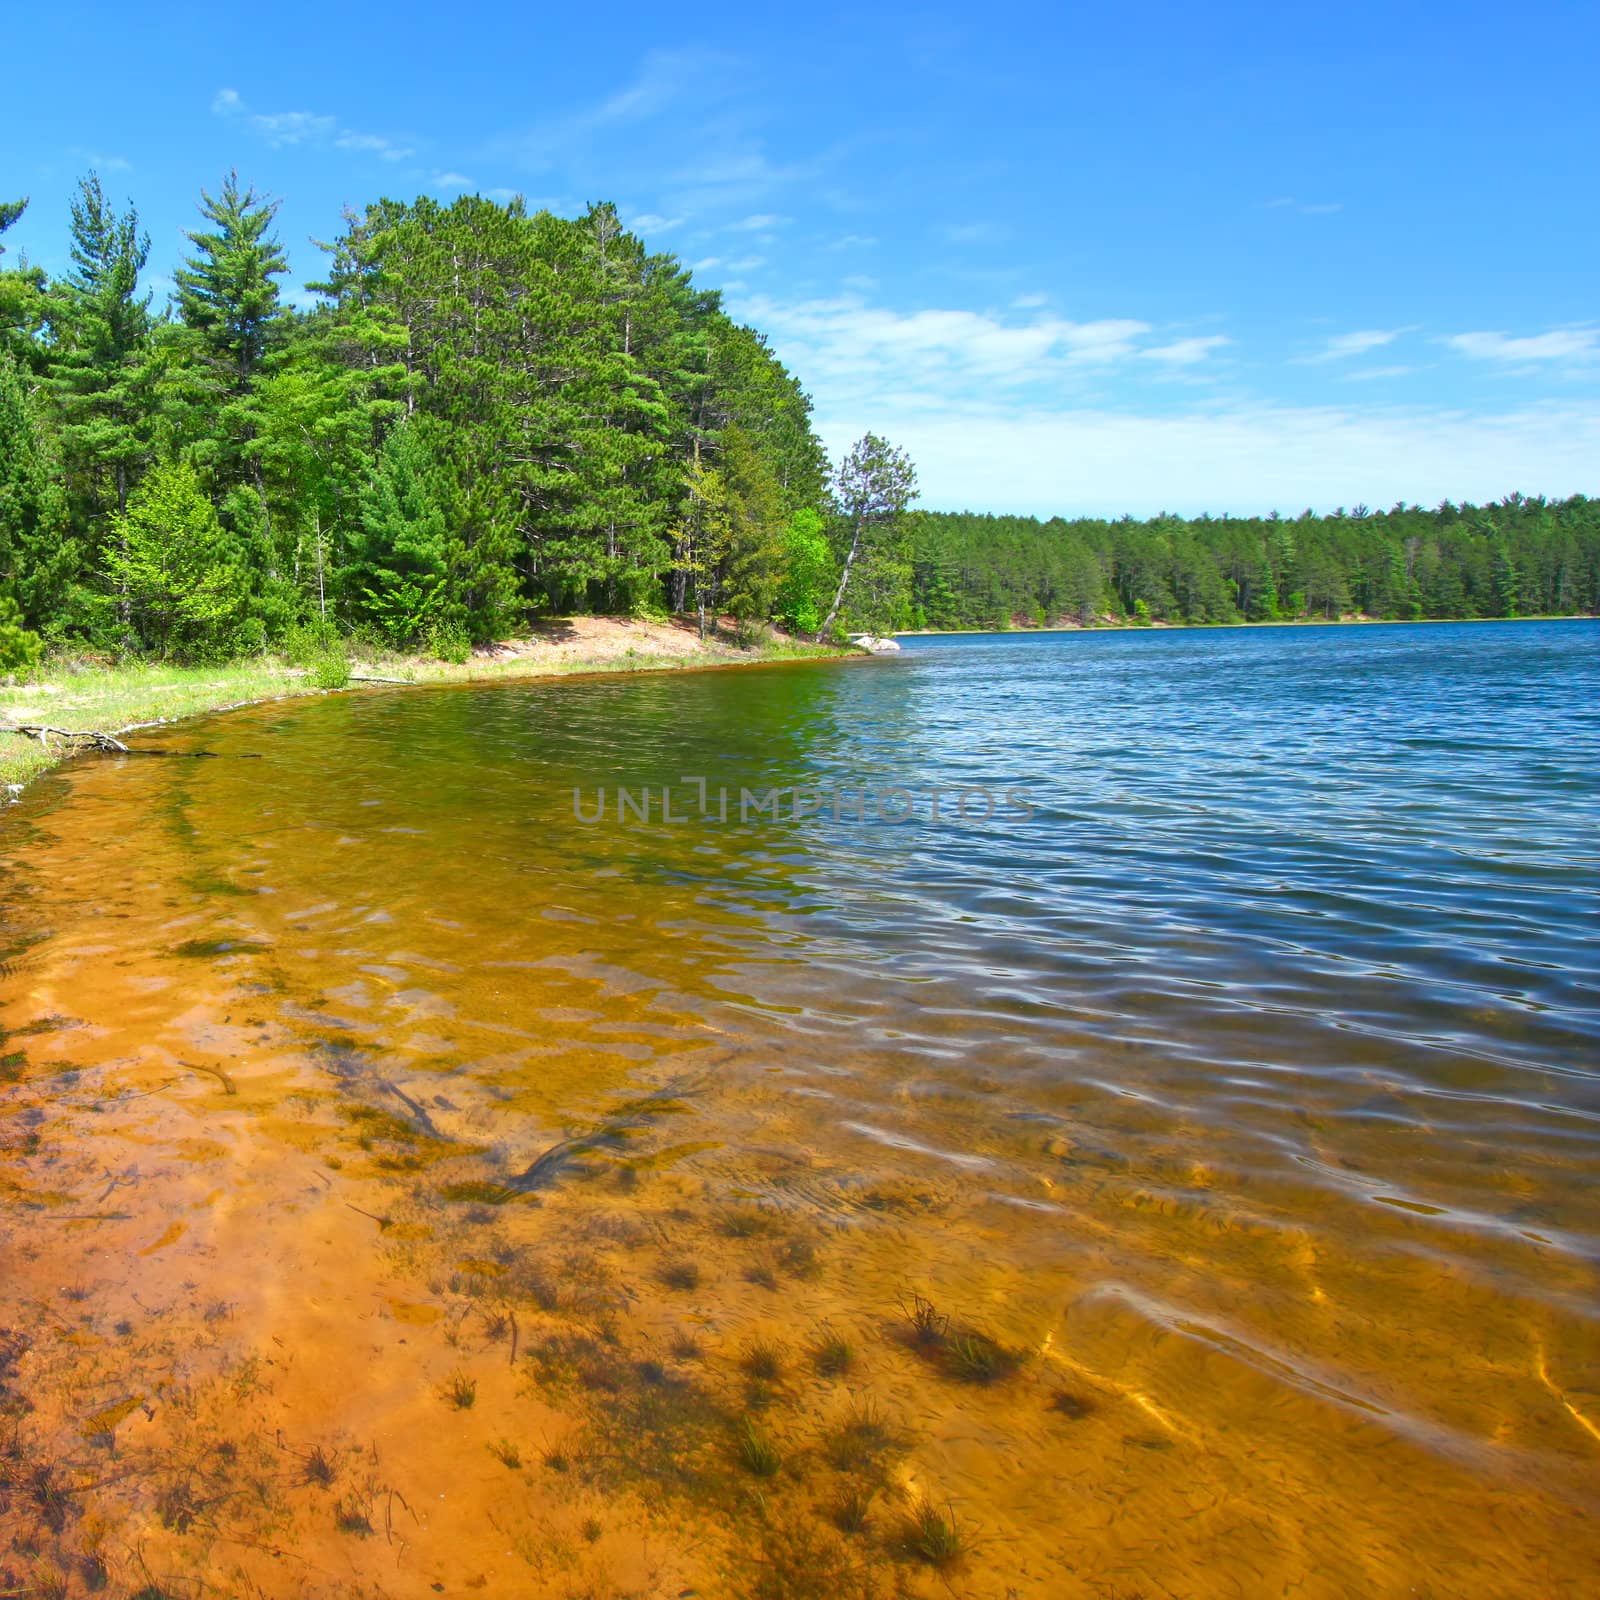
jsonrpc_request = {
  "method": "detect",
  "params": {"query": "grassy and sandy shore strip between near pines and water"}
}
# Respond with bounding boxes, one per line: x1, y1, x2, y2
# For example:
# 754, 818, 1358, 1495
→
0, 618, 862, 800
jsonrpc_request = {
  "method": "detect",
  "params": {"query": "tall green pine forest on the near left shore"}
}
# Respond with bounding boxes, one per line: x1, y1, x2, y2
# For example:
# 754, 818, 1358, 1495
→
0, 173, 915, 670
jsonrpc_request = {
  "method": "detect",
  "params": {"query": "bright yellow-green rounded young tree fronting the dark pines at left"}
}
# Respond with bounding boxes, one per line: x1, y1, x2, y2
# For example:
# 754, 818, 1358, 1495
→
112, 462, 250, 661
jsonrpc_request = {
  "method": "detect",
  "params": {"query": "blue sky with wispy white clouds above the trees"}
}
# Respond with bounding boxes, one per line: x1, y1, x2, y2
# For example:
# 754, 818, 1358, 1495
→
0, 0, 1600, 514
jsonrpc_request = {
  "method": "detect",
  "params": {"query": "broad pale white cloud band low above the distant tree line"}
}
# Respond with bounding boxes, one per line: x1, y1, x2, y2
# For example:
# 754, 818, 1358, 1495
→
819, 398, 1600, 517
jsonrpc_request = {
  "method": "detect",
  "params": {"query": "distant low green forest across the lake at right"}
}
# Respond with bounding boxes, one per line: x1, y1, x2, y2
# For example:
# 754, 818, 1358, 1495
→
904, 494, 1600, 629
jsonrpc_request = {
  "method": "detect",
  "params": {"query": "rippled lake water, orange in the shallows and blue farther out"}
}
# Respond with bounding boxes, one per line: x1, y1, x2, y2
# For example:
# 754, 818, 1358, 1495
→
0, 624, 1600, 1600
